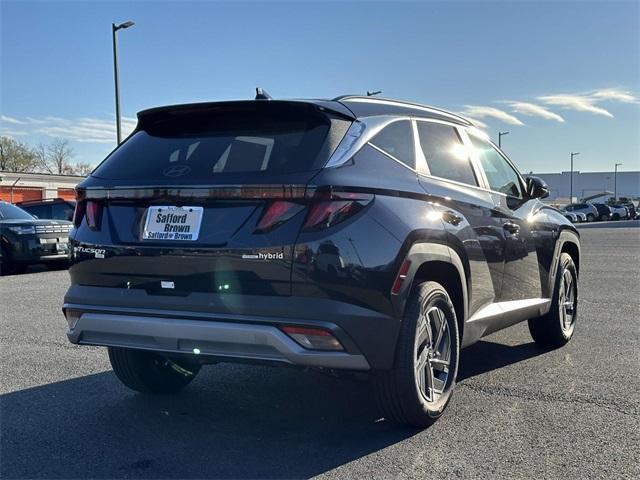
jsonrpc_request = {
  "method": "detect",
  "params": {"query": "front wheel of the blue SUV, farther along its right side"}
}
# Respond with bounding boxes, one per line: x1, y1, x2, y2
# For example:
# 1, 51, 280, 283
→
529, 252, 578, 348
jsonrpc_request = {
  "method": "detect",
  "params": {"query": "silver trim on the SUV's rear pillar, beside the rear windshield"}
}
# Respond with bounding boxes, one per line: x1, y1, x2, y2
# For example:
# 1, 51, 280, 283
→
323, 115, 411, 168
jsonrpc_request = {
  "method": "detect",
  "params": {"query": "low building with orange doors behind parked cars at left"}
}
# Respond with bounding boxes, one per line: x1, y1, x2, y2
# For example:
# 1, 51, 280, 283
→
0, 171, 84, 203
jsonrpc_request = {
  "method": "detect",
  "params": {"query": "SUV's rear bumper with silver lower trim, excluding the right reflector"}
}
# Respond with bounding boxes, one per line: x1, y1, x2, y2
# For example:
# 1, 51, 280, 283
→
64, 285, 399, 371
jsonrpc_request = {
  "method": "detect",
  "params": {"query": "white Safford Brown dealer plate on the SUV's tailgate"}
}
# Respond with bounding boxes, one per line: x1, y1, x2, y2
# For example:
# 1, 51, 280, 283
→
142, 205, 204, 242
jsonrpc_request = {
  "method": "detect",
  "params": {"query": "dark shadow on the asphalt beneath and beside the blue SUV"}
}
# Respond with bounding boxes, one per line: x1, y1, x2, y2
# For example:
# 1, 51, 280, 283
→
0, 341, 552, 478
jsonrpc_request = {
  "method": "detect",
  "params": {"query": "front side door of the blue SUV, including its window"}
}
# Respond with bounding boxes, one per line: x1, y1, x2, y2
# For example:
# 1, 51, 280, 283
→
468, 133, 549, 302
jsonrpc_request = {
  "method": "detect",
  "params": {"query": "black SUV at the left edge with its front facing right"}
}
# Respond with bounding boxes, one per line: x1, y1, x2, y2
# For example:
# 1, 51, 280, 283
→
0, 201, 72, 274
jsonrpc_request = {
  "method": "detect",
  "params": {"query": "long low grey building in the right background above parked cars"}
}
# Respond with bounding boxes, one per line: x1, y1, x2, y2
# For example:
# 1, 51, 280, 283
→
531, 170, 640, 203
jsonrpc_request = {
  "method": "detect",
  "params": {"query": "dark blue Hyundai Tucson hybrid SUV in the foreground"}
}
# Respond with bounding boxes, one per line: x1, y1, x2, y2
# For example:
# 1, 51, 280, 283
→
63, 96, 580, 426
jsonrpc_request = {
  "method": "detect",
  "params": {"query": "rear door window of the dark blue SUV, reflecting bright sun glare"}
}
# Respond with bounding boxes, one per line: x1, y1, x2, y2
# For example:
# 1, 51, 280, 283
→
418, 121, 478, 185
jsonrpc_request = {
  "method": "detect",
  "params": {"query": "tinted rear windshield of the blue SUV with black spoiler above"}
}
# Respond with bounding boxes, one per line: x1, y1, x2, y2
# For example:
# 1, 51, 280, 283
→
92, 102, 350, 180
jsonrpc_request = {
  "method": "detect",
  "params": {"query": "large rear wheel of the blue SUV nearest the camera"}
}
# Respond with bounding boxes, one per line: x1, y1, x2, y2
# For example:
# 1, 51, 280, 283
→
371, 282, 460, 427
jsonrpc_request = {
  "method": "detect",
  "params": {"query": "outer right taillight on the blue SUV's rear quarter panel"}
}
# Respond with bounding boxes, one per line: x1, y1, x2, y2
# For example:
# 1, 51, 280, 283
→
303, 192, 373, 231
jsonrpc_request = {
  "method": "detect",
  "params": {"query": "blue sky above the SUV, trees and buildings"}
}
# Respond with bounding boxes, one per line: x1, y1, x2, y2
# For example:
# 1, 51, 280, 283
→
0, 0, 640, 172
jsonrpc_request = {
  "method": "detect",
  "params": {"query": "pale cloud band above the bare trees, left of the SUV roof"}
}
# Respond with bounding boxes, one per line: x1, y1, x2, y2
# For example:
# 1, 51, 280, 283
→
0, 115, 137, 143
